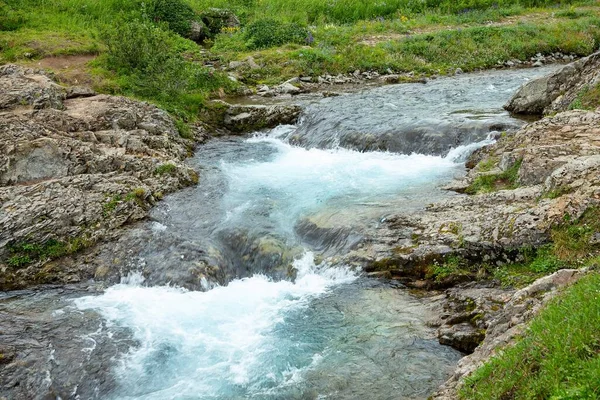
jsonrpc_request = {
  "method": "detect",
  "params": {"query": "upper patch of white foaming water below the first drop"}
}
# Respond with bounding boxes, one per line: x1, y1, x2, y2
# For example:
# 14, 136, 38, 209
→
221, 131, 468, 235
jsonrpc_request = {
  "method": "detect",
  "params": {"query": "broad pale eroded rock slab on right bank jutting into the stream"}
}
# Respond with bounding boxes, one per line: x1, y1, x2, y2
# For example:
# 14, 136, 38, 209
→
347, 110, 600, 281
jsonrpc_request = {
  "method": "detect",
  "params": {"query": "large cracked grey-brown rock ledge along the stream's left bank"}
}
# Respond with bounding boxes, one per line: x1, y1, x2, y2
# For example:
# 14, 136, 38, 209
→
0, 65, 206, 290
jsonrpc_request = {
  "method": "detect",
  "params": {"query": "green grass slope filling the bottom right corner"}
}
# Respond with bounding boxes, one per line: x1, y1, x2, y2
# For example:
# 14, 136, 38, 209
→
460, 273, 600, 400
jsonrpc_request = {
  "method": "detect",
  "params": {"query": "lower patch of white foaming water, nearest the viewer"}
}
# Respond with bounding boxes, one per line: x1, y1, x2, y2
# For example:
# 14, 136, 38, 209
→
75, 253, 356, 399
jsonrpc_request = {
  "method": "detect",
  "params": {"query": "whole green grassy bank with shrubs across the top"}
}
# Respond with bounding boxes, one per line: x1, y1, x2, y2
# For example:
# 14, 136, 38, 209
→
0, 0, 600, 120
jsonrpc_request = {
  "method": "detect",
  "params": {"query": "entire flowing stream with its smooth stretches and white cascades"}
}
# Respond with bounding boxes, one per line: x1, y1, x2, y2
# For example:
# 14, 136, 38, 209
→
0, 69, 549, 399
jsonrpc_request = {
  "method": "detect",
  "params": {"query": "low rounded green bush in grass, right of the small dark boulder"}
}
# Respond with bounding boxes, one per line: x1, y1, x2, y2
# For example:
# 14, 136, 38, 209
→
246, 19, 309, 49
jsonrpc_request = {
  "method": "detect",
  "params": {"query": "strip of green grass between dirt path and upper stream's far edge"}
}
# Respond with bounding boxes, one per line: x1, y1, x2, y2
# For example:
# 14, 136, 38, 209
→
213, 13, 600, 84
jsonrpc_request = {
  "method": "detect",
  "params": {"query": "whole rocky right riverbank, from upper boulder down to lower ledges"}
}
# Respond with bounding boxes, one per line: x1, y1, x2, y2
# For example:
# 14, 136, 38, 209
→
338, 54, 600, 399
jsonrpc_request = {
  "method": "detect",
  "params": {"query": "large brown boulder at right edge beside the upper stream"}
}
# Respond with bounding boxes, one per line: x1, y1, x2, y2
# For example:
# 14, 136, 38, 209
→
504, 52, 600, 115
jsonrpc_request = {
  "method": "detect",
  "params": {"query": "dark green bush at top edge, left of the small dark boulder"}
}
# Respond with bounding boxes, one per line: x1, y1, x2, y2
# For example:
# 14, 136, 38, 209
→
148, 0, 196, 37
